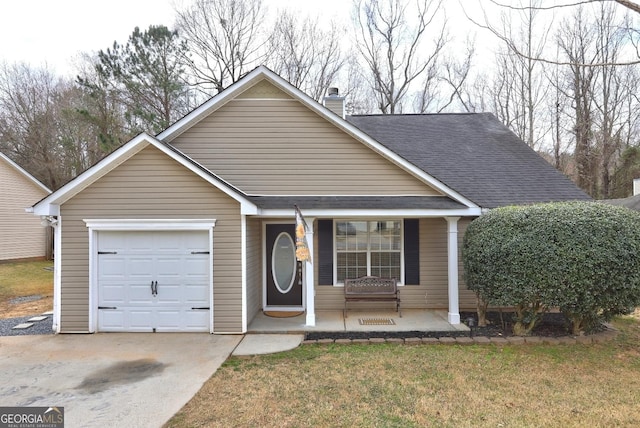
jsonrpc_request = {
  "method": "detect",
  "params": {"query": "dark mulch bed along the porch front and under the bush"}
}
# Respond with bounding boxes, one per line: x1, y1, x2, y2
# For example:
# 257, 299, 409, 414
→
305, 311, 604, 340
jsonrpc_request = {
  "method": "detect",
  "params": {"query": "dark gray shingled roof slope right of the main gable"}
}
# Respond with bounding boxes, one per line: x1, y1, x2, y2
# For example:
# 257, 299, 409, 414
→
347, 113, 591, 208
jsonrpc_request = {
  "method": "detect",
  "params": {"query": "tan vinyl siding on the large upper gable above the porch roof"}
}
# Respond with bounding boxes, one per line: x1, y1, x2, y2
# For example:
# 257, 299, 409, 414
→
171, 85, 439, 195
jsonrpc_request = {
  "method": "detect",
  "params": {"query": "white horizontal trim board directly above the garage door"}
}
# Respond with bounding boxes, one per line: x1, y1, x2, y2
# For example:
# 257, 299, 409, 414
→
82, 218, 216, 231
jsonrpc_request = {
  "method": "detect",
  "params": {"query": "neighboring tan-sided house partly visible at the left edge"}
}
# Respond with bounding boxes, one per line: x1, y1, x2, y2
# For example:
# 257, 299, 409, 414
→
0, 153, 51, 262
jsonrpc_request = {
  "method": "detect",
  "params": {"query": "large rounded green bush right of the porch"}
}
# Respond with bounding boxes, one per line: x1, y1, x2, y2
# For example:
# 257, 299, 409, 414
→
462, 202, 640, 334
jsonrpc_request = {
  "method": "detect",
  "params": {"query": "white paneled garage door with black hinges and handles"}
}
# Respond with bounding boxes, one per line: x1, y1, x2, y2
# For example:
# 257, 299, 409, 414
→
97, 231, 211, 332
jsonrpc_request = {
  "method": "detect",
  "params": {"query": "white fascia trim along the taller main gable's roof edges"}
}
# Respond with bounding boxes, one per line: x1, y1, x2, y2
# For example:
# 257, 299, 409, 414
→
158, 66, 477, 209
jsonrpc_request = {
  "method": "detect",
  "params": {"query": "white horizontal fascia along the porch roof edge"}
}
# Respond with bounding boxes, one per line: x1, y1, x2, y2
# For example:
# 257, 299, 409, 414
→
259, 207, 482, 218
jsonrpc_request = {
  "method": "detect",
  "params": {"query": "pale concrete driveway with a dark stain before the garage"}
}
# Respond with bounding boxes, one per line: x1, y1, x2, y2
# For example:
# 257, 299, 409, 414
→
0, 333, 243, 428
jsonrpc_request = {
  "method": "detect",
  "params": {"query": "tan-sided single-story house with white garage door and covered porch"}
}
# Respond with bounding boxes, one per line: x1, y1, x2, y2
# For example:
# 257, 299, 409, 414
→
34, 67, 588, 333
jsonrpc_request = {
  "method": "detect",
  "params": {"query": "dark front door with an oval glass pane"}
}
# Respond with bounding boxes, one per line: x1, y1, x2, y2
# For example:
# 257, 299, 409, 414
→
265, 224, 303, 311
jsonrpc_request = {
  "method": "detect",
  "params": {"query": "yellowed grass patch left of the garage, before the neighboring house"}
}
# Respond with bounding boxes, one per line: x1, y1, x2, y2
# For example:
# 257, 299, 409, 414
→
0, 261, 53, 318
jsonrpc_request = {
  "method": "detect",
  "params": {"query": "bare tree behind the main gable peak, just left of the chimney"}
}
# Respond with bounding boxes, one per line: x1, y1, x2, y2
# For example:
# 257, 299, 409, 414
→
268, 12, 345, 100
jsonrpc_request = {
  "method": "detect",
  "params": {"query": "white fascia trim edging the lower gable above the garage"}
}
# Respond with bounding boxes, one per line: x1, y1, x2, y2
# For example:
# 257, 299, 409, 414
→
33, 133, 257, 215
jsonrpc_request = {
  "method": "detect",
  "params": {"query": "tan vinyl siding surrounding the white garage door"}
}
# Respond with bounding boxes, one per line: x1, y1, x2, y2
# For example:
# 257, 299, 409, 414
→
61, 146, 242, 332
